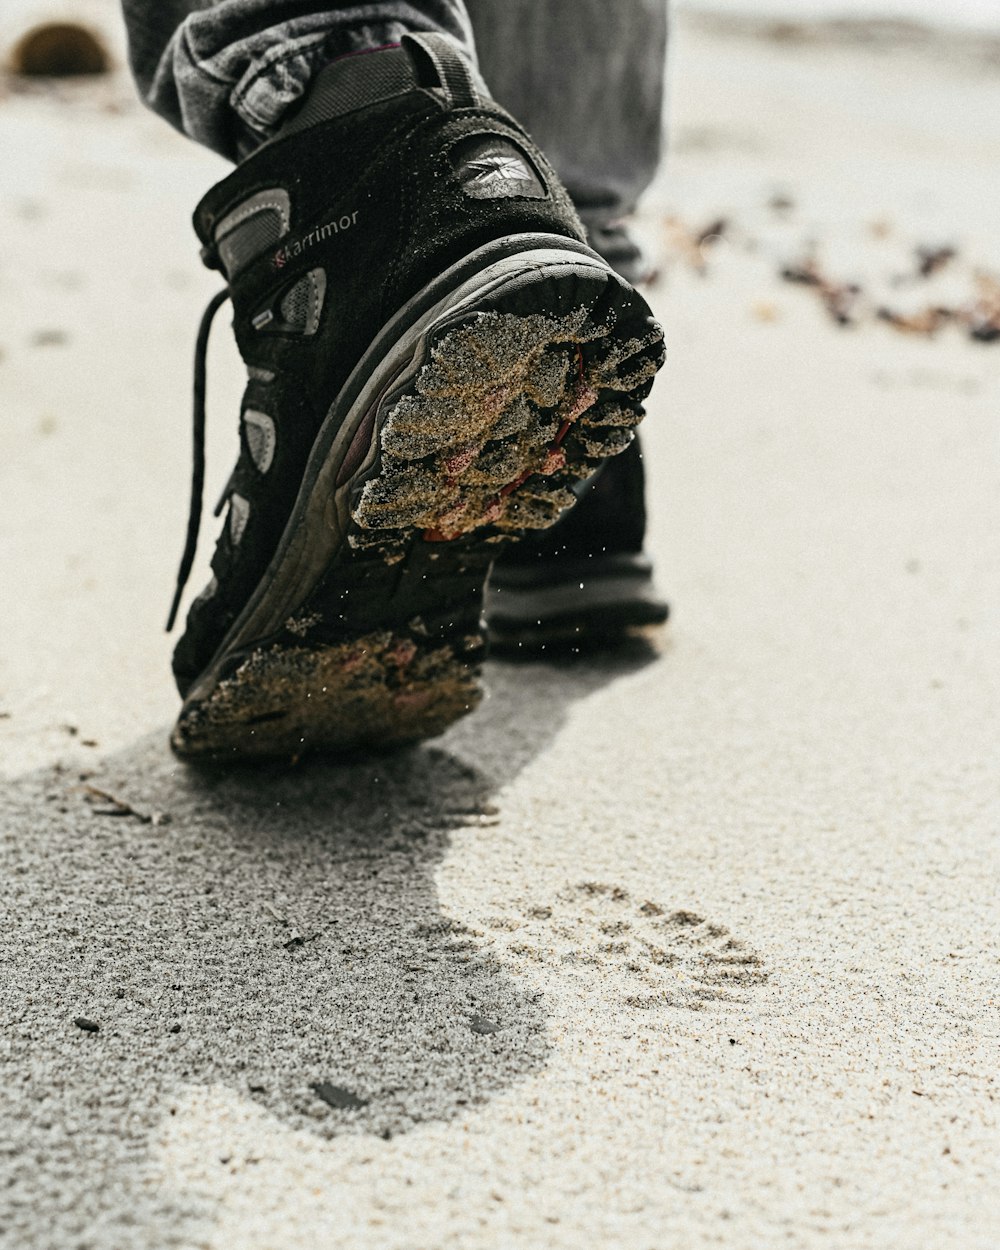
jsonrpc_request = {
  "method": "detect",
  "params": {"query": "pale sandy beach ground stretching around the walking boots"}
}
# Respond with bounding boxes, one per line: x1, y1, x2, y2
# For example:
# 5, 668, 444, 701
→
0, 12, 1000, 1250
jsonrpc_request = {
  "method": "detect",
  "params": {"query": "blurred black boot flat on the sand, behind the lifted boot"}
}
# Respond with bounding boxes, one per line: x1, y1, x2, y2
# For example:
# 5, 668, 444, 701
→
486, 439, 670, 656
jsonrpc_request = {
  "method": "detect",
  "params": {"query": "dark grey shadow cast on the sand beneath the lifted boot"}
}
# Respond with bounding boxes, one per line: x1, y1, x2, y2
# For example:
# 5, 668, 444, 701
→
3, 644, 654, 1244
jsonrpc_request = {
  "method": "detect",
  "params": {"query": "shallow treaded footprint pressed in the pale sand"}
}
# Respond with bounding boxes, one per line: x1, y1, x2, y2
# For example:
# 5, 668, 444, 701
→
488, 881, 768, 1010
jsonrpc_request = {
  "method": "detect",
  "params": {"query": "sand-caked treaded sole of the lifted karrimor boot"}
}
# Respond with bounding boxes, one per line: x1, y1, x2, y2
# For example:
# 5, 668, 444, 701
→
171, 235, 664, 759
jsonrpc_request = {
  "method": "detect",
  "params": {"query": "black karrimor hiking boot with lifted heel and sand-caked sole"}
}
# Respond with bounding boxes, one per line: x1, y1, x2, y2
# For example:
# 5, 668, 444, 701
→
171, 36, 663, 758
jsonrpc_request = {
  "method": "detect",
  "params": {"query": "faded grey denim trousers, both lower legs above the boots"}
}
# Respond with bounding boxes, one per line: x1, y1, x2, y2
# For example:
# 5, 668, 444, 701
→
123, 0, 668, 229
